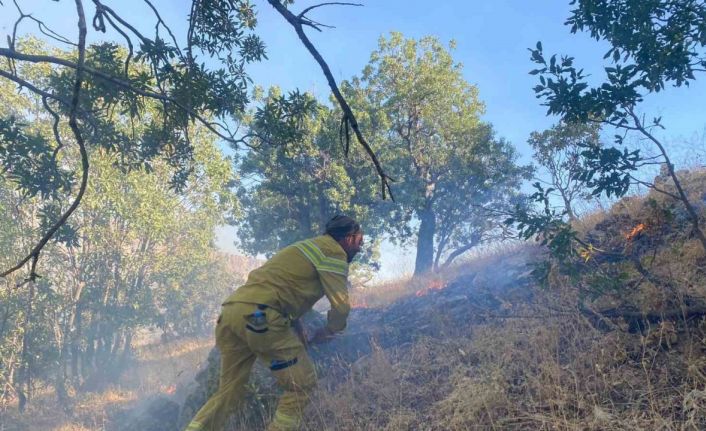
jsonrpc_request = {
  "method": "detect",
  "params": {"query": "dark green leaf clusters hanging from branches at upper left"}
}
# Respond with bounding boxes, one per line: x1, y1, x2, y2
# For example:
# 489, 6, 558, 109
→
0, 21, 310, 264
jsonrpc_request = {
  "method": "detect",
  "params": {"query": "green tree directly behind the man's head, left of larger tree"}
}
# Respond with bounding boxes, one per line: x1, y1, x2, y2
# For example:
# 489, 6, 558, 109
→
238, 88, 384, 268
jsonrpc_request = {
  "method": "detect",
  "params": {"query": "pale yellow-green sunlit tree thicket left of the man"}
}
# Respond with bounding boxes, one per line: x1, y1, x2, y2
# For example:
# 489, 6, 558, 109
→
0, 143, 235, 406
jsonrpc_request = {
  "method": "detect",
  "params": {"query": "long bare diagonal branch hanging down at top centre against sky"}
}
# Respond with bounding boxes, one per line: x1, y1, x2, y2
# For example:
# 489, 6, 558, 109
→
267, 0, 395, 200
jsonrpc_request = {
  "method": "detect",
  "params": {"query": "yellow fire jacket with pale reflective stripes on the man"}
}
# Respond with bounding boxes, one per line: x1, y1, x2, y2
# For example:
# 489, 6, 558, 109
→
223, 235, 350, 332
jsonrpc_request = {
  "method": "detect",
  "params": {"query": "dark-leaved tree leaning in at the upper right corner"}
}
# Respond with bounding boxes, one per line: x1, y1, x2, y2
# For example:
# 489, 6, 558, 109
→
530, 0, 706, 250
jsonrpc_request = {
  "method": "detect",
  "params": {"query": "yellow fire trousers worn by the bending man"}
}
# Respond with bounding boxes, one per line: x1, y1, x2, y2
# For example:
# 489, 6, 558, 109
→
186, 303, 316, 431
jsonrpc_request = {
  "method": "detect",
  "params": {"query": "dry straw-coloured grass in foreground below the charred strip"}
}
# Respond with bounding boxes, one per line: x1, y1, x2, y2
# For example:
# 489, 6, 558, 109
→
305, 296, 706, 431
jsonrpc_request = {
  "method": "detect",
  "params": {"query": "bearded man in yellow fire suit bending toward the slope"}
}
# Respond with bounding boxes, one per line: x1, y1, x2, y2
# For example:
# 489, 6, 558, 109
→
186, 215, 363, 431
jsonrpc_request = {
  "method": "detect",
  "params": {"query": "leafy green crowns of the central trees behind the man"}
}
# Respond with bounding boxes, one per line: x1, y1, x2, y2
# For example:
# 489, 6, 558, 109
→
239, 33, 530, 271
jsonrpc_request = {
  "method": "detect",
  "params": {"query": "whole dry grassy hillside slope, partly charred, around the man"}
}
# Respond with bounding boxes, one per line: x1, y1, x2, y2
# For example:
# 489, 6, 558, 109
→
123, 172, 706, 431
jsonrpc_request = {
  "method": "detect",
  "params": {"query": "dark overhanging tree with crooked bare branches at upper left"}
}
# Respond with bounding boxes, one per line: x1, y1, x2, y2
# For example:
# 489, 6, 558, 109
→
0, 0, 389, 281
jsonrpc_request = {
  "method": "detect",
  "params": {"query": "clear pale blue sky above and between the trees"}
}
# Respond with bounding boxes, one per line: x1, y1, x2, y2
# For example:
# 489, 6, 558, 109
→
0, 0, 706, 278
